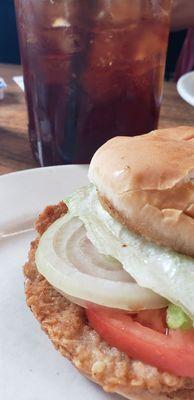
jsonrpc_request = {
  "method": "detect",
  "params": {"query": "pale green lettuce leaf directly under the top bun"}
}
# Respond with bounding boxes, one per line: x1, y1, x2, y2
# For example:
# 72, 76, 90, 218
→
68, 185, 194, 326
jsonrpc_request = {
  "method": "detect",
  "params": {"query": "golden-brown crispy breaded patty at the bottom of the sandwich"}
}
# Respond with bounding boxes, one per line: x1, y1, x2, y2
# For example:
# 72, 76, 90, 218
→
24, 202, 194, 400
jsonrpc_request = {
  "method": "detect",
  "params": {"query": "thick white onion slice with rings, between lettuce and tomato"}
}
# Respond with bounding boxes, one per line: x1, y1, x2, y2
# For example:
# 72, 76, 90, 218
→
35, 213, 166, 311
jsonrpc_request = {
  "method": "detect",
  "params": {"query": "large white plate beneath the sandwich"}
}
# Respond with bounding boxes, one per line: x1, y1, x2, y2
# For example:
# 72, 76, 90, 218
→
0, 166, 119, 400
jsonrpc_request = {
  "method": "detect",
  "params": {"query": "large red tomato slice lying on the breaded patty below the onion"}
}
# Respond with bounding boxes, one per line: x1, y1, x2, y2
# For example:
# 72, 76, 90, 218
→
86, 307, 194, 378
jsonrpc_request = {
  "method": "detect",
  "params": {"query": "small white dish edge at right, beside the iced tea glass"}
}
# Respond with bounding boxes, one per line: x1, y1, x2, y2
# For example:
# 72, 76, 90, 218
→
177, 71, 194, 106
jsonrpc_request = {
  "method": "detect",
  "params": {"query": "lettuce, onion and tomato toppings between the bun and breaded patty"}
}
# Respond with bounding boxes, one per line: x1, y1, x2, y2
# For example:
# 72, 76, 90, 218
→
36, 185, 194, 377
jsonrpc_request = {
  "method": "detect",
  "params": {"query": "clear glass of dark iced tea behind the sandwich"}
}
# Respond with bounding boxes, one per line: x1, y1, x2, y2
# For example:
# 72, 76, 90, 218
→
15, 0, 171, 166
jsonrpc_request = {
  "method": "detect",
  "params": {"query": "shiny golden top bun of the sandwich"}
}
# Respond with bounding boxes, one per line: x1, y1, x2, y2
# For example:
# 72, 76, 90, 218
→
89, 126, 194, 256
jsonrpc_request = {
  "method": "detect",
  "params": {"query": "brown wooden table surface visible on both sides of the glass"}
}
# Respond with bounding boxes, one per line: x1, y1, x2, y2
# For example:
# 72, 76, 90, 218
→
0, 64, 194, 175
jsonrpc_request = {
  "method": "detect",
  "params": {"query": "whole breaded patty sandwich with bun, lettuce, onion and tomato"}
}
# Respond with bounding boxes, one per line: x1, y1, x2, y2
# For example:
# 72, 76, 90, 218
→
24, 127, 194, 400
